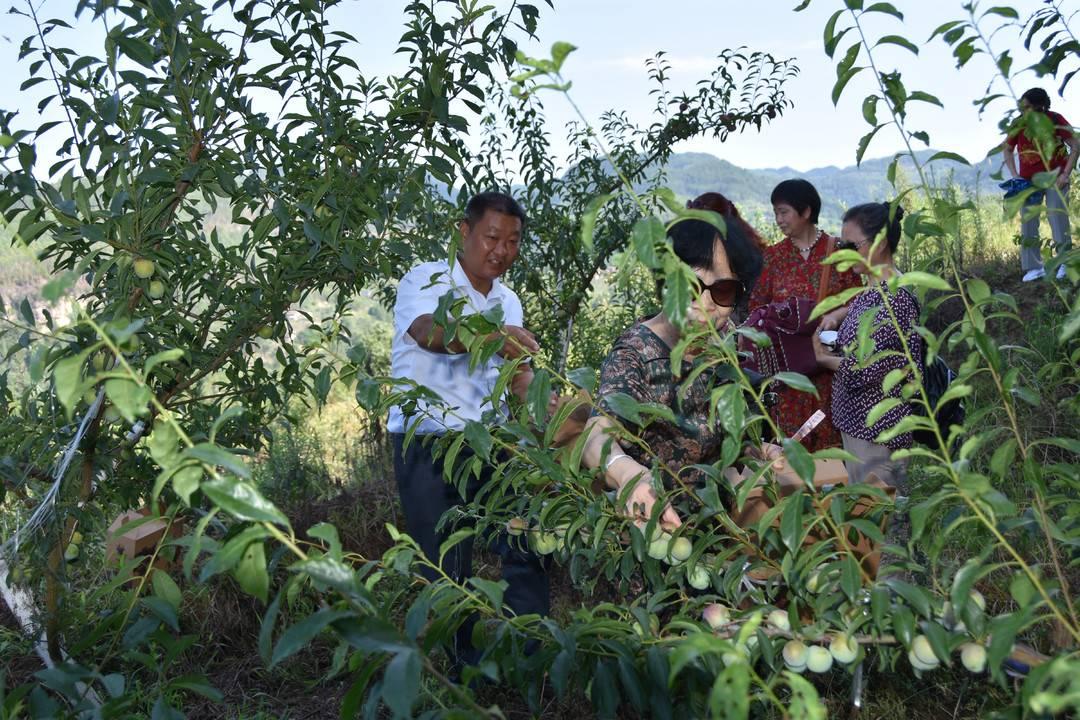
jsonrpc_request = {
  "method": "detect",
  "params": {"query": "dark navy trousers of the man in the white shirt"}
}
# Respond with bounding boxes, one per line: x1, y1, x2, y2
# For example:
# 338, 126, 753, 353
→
391, 433, 551, 665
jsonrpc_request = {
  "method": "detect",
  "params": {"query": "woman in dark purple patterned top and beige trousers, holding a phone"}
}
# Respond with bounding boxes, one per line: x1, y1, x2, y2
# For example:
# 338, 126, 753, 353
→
814, 203, 922, 494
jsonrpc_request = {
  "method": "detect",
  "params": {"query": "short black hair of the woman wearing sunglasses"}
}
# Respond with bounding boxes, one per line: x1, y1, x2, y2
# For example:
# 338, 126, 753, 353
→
667, 214, 762, 305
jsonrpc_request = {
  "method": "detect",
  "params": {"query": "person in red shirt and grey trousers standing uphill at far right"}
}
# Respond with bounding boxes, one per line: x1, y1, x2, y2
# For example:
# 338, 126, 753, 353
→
1002, 87, 1080, 283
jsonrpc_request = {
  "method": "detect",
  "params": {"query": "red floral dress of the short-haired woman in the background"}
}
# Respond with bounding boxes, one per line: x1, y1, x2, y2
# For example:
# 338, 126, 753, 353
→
750, 231, 862, 451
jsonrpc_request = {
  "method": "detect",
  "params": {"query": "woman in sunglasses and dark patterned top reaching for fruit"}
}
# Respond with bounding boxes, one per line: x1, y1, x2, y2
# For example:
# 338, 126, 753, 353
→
583, 215, 774, 528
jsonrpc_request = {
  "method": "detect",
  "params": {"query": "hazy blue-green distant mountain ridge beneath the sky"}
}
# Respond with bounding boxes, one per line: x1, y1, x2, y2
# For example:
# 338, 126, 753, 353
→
667, 150, 1001, 226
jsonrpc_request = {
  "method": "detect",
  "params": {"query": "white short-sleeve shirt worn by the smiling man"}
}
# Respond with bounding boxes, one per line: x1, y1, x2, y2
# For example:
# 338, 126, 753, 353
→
387, 260, 524, 435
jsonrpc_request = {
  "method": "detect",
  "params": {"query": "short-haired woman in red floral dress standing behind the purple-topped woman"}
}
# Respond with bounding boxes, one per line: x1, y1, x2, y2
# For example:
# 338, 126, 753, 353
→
750, 180, 861, 450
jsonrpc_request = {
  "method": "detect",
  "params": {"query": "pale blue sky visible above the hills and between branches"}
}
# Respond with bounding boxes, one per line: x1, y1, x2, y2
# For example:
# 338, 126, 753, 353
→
0, 0, 1080, 169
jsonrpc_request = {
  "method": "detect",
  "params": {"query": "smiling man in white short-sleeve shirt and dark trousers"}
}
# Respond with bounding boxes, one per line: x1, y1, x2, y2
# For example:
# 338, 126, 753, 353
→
388, 192, 550, 664
